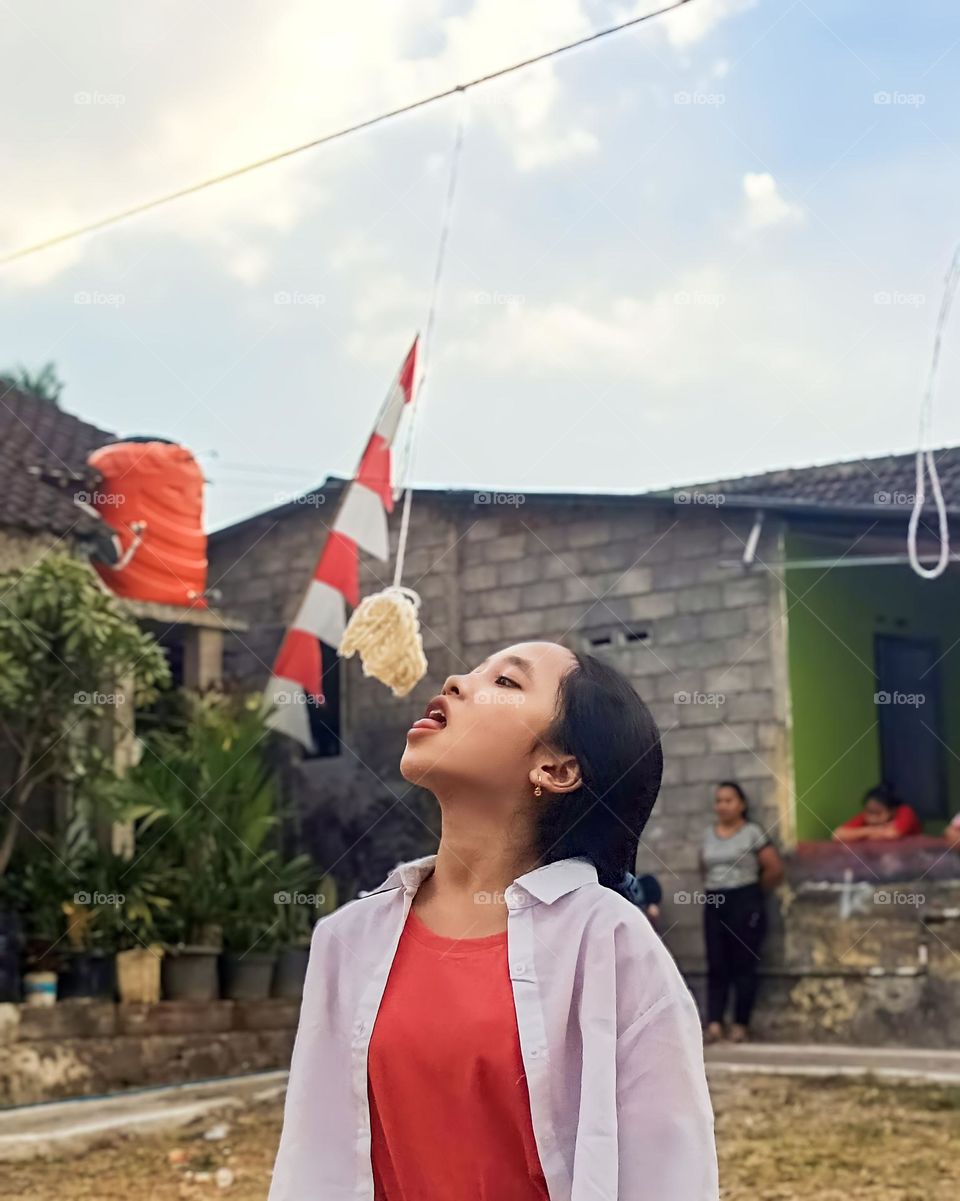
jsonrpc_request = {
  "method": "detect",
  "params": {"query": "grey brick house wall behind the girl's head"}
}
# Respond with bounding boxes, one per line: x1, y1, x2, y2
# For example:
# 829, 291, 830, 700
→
210, 494, 791, 967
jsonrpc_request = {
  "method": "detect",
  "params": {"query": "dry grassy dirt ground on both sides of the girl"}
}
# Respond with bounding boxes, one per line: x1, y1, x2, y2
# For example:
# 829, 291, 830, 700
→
0, 1075, 960, 1201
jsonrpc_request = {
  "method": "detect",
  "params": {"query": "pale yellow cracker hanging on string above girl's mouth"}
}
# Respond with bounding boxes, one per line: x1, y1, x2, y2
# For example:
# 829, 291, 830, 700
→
340, 586, 427, 697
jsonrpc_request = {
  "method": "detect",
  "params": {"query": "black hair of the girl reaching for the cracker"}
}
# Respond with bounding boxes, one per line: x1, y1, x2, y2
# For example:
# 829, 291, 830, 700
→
536, 652, 663, 890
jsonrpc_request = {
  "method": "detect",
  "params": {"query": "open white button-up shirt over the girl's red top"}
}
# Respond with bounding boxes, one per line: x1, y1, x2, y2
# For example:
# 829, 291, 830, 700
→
268, 855, 718, 1201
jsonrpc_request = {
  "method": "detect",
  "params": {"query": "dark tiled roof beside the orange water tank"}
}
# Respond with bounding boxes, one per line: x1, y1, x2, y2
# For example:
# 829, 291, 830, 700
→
0, 382, 114, 534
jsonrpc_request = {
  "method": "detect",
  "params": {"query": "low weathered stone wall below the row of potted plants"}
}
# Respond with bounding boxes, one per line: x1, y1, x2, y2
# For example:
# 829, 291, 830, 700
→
0, 1000, 300, 1106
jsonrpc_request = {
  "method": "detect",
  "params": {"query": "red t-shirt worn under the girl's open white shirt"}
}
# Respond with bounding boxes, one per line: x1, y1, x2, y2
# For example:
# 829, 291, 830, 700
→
365, 909, 549, 1201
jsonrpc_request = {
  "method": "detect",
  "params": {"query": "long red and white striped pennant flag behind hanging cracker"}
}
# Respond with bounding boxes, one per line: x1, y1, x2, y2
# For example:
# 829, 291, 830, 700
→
263, 337, 419, 751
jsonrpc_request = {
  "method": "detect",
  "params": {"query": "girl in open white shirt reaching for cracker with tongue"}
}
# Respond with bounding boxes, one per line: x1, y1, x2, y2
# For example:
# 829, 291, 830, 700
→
269, 643, 718, 1201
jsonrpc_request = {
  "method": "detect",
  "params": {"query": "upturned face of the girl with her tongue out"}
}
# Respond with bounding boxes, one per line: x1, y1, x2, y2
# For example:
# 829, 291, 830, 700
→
400, 643, 579, 799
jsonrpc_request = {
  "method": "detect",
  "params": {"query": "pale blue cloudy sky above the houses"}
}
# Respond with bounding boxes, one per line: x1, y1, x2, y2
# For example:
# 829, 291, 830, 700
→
0, 0, 960, 527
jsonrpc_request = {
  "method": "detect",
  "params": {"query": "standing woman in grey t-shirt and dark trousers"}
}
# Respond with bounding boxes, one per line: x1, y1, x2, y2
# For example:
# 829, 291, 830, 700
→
700, 779, 783, 1042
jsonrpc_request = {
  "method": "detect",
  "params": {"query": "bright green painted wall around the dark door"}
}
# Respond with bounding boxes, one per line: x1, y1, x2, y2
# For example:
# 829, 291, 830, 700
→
785, 532, 960, 839
